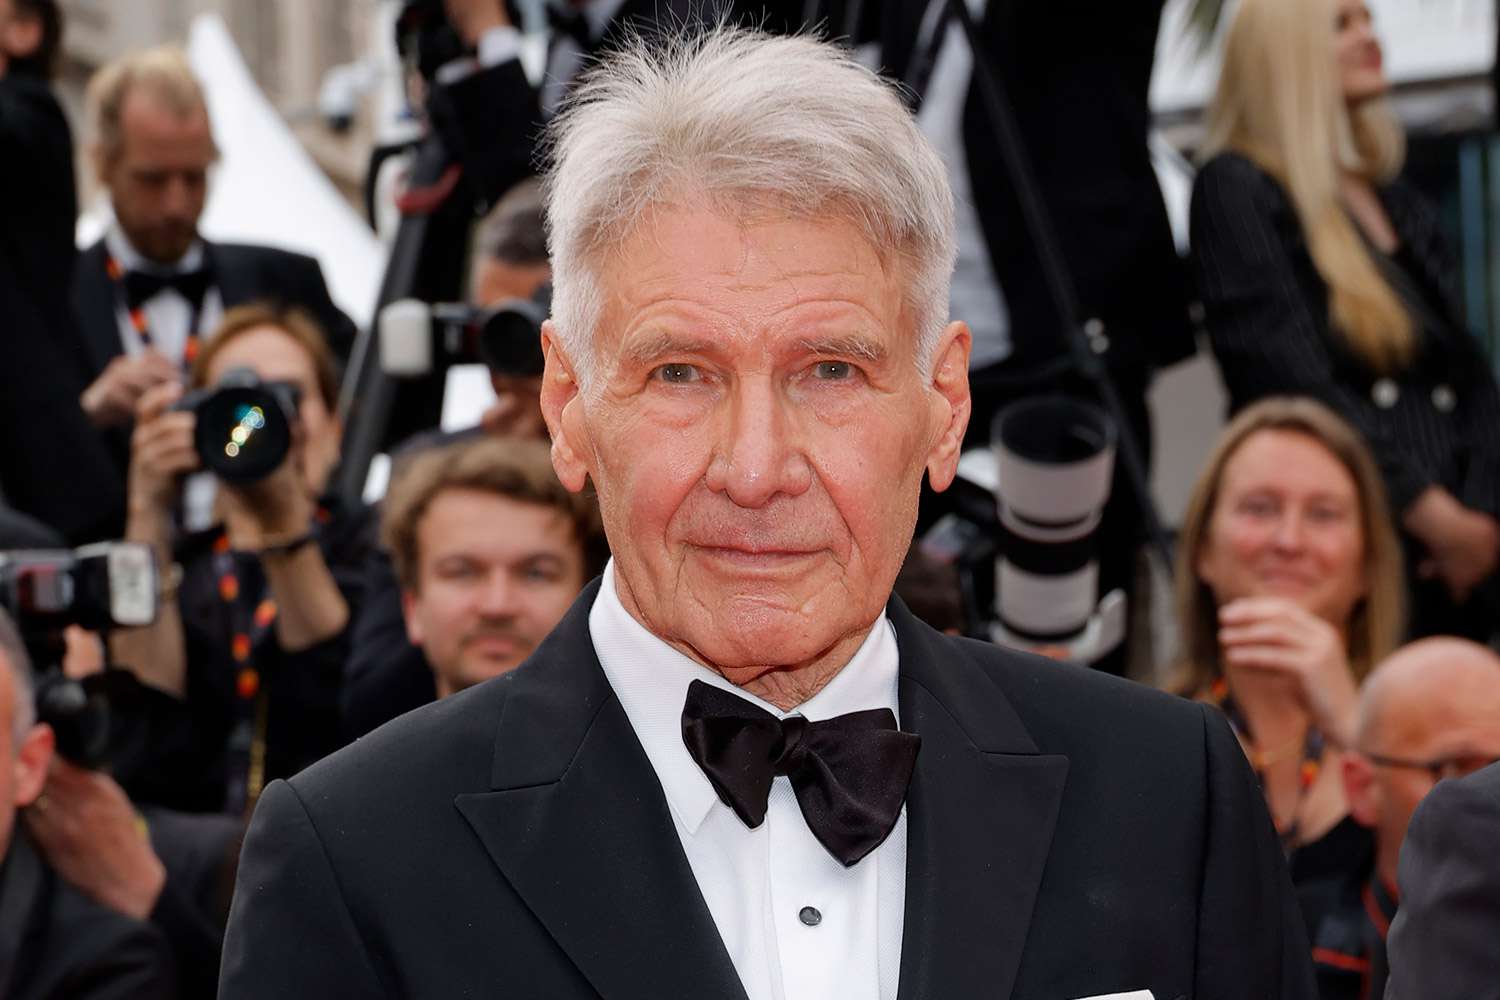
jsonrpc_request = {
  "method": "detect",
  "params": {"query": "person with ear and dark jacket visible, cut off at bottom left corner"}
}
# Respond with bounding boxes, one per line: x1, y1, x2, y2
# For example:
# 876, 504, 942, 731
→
0, 612, 176, 1000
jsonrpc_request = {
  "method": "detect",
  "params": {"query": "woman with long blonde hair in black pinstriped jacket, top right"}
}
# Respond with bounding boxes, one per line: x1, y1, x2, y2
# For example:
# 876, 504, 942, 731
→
1193, 0, 1500, 639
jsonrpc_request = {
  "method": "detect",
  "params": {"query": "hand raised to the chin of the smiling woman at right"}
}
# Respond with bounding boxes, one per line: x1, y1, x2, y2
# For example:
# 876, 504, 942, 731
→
1220, 597, 1359, 747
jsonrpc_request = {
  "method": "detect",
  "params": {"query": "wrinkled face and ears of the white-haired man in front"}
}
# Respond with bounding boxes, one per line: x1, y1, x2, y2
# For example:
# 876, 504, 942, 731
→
543, 208, 969, 684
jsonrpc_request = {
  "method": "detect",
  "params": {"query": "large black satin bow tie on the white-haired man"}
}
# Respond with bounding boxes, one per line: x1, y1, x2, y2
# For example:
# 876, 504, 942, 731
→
683, 681, 923, 868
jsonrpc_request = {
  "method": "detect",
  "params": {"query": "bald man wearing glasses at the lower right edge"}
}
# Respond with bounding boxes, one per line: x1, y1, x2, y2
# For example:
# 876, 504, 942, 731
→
1299, 639, 1500, 1000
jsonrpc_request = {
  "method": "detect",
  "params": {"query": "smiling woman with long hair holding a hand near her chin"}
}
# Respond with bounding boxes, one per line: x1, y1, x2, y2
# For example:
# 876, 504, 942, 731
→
1173, 397, 1404, 882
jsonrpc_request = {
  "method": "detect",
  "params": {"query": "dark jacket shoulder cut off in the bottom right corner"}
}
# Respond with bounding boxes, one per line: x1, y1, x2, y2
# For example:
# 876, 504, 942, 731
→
1386, 765, 1500, 1000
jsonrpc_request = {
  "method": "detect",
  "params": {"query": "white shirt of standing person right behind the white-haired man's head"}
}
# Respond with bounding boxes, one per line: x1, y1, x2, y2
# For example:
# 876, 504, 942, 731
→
914, 0, 1011, 369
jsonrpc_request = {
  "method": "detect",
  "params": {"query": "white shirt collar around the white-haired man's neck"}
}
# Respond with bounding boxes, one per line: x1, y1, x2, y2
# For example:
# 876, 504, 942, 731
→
588, 559, 900, 834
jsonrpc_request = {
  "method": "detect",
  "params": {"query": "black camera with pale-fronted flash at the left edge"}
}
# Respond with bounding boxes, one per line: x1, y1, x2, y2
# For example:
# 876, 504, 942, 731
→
0, 543, 159, 768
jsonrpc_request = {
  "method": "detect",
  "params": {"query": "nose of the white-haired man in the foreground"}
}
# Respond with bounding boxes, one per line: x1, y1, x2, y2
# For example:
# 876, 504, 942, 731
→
707, 378, 813, 507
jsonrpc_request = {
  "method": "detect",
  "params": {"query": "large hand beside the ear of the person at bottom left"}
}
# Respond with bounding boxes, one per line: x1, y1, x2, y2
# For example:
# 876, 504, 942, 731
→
26, 757, 167, 921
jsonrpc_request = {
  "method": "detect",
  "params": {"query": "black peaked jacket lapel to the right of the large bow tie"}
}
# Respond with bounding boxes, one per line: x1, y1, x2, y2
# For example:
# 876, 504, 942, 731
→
890, 600, 1068, 1000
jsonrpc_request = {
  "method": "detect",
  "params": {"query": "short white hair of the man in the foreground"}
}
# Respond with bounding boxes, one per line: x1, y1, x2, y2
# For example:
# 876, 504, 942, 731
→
546, 25, 957, 385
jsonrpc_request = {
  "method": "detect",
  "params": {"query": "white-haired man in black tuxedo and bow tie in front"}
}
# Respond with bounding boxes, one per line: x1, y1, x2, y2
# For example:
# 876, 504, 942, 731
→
221, 30, 1313, 1000
